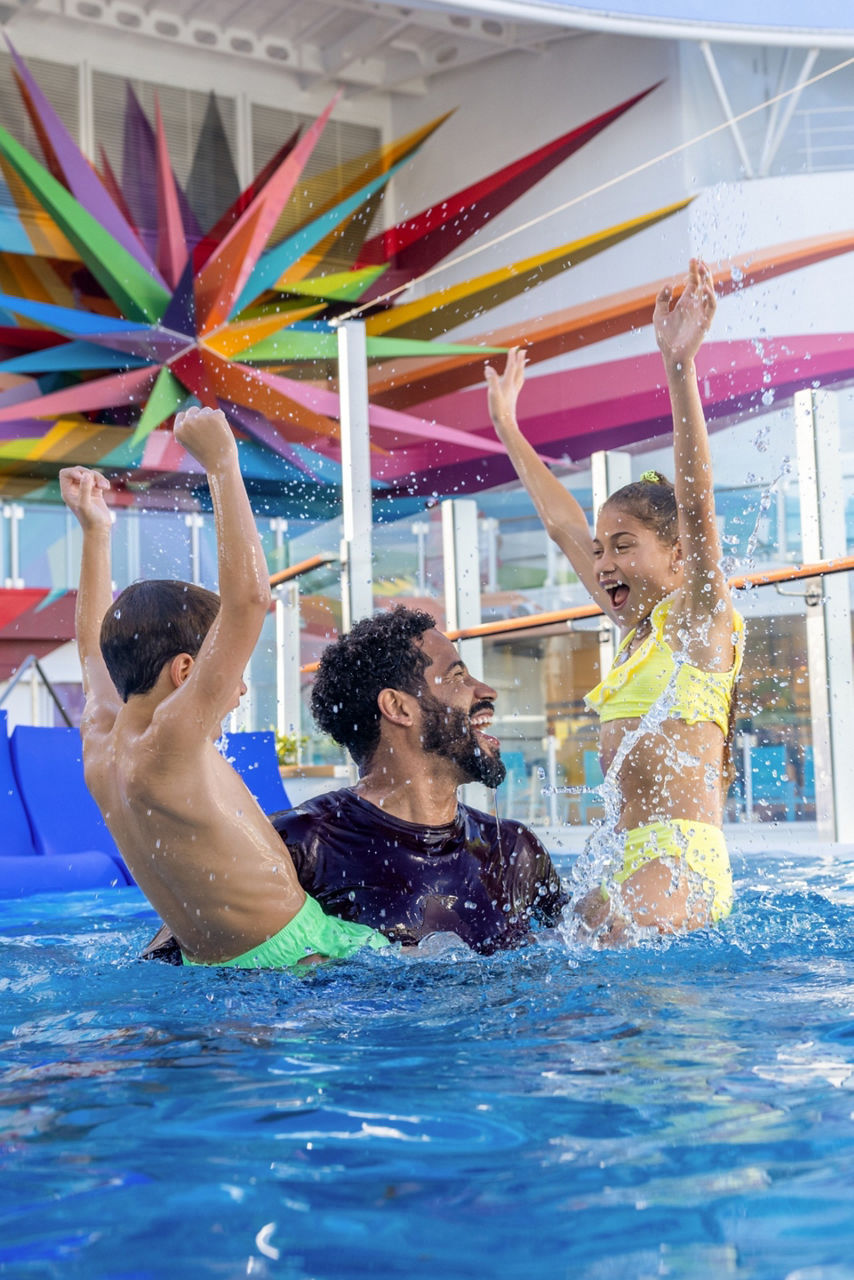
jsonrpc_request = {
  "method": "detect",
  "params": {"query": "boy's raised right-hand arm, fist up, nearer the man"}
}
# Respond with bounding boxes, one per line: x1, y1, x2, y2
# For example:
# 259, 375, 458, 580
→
170, 407, 270, 735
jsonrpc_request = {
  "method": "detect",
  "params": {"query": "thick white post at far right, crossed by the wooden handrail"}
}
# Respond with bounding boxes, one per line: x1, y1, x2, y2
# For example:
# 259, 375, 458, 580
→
793, 390, 854, 841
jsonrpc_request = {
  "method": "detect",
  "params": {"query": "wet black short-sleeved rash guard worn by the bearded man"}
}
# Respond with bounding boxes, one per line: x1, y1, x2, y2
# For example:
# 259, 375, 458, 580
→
271, 787, 568, 954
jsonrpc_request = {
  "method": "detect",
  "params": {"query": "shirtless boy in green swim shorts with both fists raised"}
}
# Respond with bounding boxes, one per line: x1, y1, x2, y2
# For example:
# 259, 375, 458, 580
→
59, 408, 387, 969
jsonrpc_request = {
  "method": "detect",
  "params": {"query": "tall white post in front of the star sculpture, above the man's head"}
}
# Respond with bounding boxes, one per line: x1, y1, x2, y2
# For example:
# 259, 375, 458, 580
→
338, 320, 374, 631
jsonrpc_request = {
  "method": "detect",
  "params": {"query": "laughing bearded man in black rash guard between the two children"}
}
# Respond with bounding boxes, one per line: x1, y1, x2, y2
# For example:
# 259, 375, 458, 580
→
273, 607, 567, 952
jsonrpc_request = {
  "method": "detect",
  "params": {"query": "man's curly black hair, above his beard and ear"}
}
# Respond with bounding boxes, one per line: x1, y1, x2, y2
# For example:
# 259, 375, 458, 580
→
311, 604, 435, 768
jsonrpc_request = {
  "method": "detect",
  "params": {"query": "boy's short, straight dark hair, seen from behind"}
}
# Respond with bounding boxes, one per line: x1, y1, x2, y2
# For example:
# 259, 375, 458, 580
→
101, 579, 219, 703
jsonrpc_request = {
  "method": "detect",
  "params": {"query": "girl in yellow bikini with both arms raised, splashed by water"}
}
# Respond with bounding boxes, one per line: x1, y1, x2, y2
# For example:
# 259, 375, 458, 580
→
487, 259, 744, 938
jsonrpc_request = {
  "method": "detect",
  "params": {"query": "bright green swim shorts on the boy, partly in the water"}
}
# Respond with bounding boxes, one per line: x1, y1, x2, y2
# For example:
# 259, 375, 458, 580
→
182, 893, 389, 969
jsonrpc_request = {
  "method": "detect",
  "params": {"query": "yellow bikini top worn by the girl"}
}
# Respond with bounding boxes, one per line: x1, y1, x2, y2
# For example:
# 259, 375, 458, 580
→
584, 598, 744, 735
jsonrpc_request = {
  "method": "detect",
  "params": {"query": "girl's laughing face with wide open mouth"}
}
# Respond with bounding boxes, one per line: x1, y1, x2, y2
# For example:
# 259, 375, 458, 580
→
593, 503, 682, 630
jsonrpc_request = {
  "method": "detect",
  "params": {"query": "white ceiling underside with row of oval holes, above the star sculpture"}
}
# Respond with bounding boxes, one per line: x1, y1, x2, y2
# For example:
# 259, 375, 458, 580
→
13, 0, 580, 93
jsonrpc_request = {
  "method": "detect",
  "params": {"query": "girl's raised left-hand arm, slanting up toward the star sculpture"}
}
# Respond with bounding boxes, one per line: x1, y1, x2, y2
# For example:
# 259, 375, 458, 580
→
487, 347, 613, 617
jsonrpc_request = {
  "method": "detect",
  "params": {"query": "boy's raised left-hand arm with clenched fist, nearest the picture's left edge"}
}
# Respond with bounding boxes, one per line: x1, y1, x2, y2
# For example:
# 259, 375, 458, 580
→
59, 467, 120, 717
